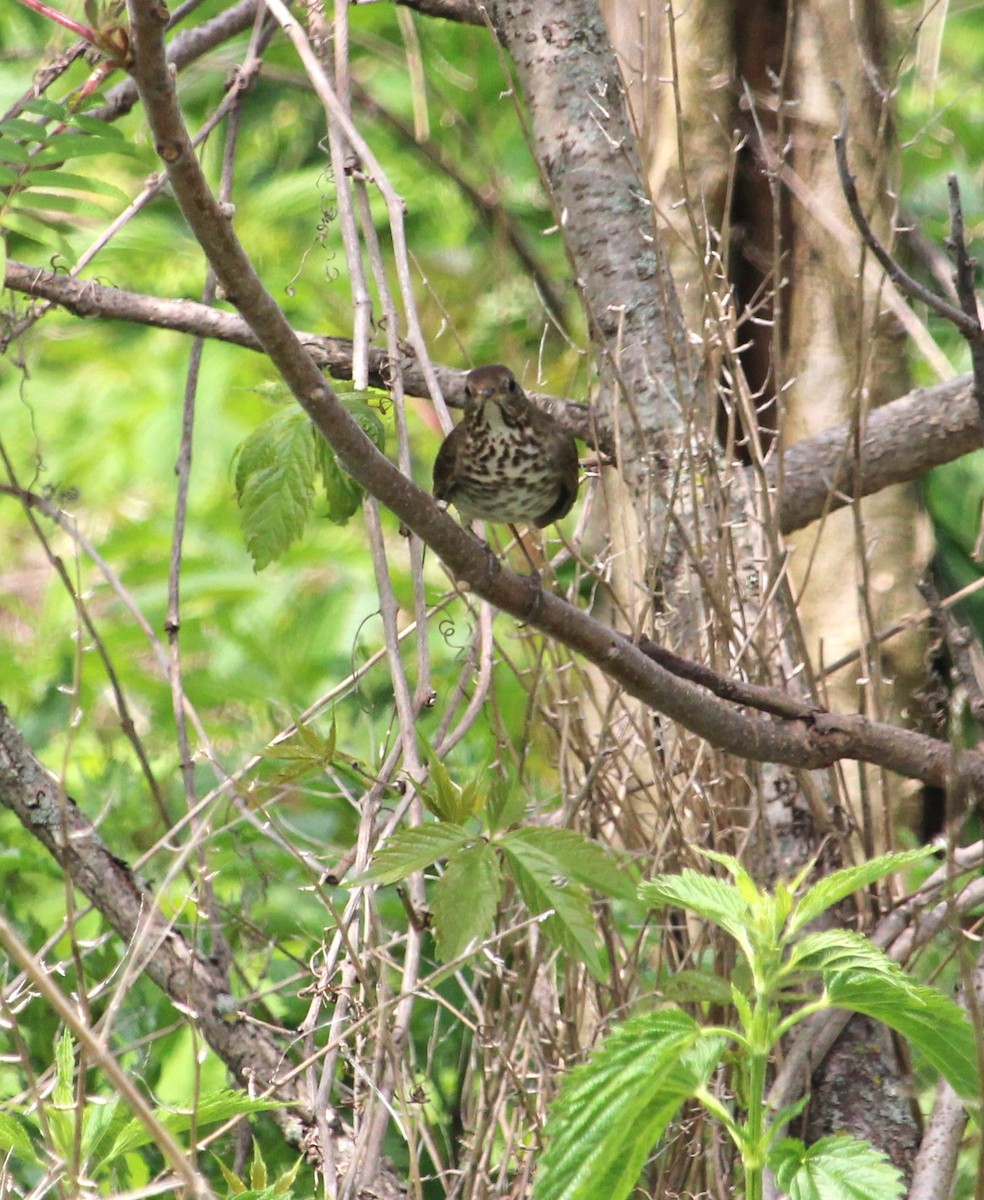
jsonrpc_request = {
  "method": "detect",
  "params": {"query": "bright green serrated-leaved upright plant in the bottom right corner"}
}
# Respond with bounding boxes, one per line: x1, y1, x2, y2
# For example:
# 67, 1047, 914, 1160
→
534, 848, 980, 1200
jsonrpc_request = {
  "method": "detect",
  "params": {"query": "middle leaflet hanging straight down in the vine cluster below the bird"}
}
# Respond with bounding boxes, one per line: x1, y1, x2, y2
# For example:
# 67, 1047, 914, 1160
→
431, 841, 503, 962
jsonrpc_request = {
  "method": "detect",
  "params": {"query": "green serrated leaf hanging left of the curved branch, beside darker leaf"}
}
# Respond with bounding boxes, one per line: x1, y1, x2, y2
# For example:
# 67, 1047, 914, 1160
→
235, 409, 314, 571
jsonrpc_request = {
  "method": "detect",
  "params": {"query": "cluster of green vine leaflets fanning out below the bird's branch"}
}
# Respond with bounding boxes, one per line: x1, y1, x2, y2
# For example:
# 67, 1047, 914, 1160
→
350, 752, 635, 979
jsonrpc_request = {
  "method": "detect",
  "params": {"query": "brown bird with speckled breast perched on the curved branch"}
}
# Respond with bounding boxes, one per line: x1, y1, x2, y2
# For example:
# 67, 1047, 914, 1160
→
434, 366, 577, 529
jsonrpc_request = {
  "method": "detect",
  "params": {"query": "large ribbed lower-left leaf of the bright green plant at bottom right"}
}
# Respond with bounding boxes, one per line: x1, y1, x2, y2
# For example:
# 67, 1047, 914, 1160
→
533, 1009, 725, 1200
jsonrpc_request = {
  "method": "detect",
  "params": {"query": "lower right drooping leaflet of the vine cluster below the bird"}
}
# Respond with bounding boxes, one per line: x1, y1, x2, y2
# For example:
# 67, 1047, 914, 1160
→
498, 829, 607, 982
